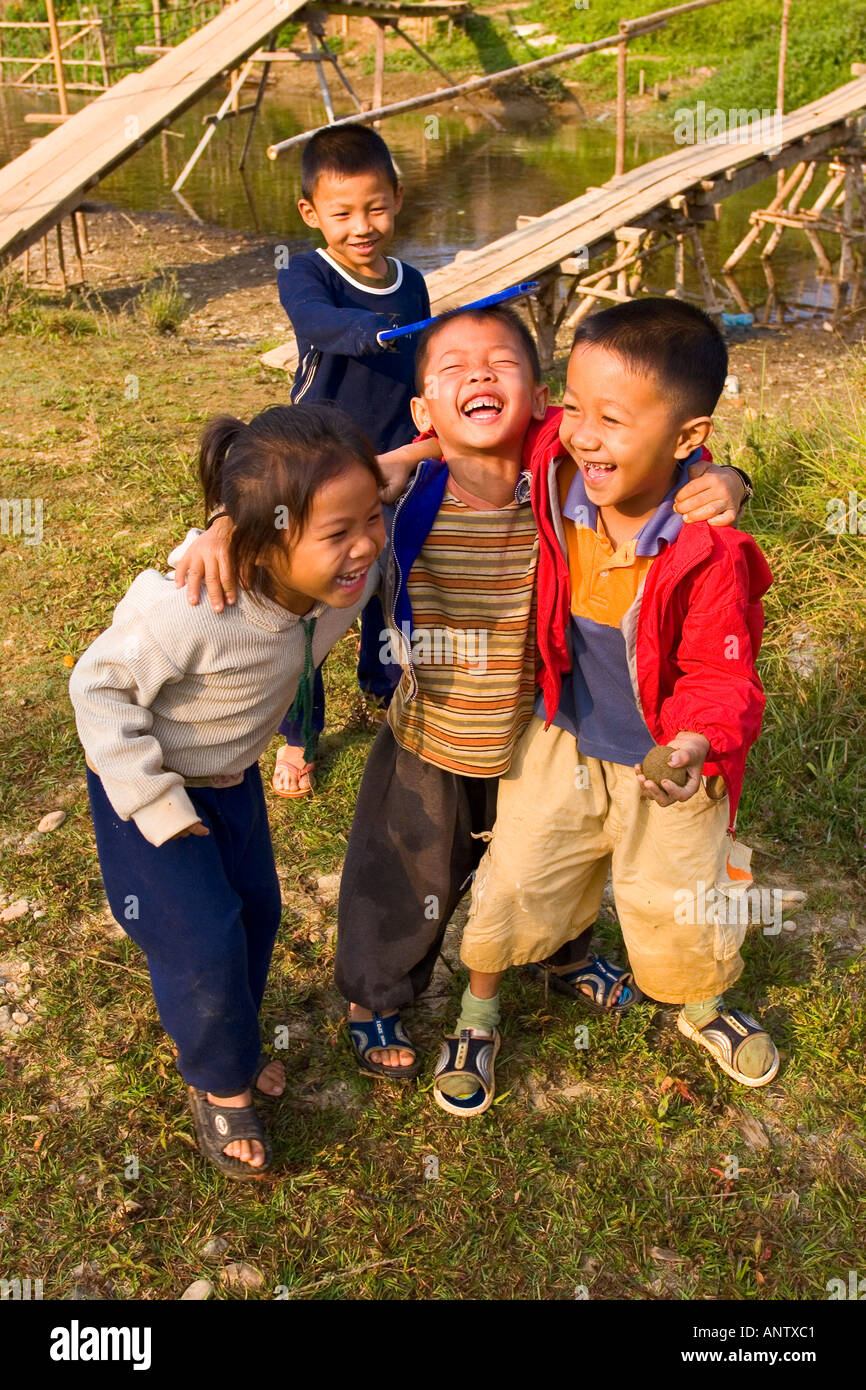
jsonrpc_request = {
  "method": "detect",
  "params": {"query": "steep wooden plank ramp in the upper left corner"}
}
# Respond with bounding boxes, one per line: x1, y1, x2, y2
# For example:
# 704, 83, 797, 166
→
0, 0, 306, 264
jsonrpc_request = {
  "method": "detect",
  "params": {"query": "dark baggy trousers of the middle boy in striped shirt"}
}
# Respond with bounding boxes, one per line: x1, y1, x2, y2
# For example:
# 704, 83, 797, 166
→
334, 724, 499, 1013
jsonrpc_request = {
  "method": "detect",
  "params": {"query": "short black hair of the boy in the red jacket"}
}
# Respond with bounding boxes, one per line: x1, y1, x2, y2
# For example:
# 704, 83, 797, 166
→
571, 296, 727, 420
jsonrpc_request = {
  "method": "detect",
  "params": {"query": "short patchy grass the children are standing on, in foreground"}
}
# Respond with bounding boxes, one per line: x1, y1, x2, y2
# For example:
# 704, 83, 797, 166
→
0, 284, 866, 1300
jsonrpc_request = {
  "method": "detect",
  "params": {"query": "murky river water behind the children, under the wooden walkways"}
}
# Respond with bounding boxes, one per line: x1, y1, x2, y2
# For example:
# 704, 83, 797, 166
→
0, 85, 838, 317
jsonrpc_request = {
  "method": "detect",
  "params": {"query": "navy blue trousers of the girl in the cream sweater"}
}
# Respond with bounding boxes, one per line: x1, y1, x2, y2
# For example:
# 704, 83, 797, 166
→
88, 765, 281, 1095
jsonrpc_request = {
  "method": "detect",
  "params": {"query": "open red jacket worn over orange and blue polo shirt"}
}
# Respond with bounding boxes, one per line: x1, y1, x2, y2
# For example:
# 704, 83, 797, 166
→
524, 410, 773, 831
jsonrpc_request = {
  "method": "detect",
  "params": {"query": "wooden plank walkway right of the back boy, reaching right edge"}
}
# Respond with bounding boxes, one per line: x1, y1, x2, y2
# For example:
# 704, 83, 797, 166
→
427, 76, 866, 313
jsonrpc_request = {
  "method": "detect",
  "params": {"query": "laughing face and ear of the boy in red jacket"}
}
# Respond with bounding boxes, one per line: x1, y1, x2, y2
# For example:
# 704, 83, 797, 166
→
559, 345, 712, 517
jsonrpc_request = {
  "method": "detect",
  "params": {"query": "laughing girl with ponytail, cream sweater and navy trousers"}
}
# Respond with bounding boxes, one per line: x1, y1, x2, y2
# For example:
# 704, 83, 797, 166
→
70, 404, 385, 1177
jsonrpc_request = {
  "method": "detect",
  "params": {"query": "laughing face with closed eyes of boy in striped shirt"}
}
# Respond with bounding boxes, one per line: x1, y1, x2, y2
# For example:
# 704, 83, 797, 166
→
411, 317, 548, 459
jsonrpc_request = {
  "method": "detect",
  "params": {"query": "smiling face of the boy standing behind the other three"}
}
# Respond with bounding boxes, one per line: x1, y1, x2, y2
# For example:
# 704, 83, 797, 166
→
297, 170, 403, 277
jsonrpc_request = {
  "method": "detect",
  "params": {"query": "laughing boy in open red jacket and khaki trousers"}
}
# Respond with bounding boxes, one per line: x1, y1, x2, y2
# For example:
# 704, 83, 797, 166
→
434, 299, 778, 1115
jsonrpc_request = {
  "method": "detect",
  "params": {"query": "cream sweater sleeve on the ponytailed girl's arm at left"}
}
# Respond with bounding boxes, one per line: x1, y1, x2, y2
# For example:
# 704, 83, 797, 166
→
70, 571, 199, 845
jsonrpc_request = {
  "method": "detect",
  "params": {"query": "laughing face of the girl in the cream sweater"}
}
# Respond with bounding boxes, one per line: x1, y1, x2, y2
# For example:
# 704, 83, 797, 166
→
263, 464, 385, 614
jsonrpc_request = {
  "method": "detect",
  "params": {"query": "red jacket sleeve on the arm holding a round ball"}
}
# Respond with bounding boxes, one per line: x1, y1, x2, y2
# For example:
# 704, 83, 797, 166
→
660, 528, 773, 759
